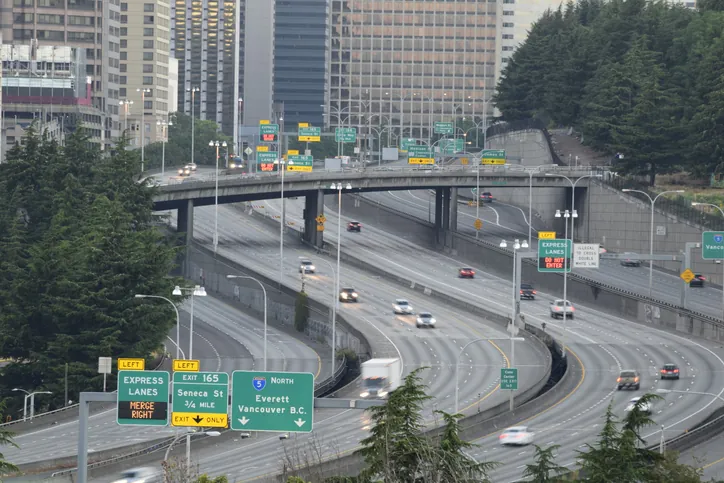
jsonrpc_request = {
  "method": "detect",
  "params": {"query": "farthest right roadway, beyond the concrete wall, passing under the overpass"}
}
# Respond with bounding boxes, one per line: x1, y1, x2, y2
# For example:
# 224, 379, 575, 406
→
364, 190, 722, 318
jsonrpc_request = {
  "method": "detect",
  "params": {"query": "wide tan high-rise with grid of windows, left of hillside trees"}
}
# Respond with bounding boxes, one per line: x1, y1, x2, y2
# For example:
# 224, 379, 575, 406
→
326, 0, 497, 144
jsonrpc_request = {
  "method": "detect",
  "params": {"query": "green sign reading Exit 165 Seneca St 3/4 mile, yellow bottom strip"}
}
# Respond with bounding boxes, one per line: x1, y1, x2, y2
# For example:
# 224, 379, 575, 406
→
171, 372, 229, 428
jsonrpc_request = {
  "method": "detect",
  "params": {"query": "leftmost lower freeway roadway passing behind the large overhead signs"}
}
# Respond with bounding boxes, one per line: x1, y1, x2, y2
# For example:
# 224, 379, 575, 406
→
4, 296, 322, 465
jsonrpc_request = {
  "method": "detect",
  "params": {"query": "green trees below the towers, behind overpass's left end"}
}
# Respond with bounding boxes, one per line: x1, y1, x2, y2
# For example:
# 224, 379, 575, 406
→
136, 112, 235, 169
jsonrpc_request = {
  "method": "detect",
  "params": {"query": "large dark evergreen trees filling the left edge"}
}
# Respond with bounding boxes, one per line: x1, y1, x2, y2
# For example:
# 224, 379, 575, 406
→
0, 128, 182, 413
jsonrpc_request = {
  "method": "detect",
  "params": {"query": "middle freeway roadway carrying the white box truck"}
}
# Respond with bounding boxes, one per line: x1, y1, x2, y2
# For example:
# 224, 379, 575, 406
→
139, 202, 548, 480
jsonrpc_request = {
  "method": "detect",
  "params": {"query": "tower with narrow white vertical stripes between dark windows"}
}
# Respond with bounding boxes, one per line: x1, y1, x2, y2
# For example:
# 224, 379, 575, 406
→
171, 0, 242, 138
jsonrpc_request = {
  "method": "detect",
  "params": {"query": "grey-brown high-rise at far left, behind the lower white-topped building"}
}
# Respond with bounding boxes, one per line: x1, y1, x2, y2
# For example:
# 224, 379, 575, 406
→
0, 0, 121, 149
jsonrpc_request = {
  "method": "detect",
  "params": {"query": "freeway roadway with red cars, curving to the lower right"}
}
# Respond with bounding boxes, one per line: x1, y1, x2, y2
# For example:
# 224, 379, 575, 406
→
252, 197, 724, 481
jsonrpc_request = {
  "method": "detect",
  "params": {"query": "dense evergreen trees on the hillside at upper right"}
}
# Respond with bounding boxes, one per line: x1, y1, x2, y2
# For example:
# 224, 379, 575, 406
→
495, 0, 724, 184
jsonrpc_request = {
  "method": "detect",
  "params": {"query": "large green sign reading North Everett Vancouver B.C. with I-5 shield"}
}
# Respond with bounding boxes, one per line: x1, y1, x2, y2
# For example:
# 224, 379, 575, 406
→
231, 371, 314, 433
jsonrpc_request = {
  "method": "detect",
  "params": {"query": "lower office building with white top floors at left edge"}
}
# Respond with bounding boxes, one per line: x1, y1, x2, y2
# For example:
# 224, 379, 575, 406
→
0, 43, 105, 159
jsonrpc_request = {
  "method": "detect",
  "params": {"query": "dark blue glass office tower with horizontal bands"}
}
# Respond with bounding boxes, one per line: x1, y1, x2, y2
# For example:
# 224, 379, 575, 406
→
274, 0, 330, 130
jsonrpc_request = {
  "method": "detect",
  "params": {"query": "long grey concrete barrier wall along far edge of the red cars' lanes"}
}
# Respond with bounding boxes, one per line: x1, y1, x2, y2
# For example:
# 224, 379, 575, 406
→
355, 195, 724, 342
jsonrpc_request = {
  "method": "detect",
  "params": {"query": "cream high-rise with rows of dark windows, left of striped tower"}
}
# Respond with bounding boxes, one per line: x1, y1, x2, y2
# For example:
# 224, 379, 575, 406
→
119, 0, 175, 147
